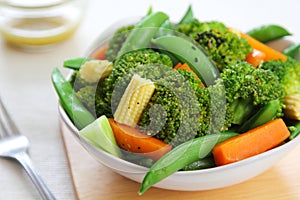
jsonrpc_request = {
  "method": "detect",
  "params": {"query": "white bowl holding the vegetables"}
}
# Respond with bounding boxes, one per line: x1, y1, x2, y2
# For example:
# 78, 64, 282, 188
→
59, 18, 300, 191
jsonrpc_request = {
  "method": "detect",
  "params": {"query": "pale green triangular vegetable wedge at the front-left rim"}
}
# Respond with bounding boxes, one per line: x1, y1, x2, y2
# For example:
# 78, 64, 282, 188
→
79, 115, 121, 157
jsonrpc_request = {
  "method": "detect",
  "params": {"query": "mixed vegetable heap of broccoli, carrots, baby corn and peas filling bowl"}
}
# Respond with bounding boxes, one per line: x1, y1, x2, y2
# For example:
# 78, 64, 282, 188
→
52, 7, 300, 194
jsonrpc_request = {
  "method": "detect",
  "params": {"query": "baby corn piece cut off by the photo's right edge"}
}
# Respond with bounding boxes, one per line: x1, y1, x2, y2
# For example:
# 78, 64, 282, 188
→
284, 94, 300, 120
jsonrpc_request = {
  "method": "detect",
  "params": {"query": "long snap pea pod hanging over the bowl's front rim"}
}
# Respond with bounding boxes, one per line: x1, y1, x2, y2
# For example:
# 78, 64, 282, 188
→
139, 132, 238, 195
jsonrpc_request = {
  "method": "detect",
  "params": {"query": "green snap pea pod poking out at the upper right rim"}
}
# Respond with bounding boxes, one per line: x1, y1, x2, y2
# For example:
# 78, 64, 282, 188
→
247, 24, 291, 43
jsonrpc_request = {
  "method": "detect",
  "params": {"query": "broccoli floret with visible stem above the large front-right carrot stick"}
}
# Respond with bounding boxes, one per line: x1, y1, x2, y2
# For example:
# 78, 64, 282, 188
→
221, 62, 284, 125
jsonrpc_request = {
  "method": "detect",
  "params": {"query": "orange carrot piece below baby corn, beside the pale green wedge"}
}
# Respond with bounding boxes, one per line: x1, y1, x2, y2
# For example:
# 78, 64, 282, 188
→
108, 118, 172, 160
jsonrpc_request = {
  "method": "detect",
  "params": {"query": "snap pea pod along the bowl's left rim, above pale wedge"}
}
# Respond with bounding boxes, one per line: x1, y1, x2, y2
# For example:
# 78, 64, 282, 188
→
51, 68, 95, 129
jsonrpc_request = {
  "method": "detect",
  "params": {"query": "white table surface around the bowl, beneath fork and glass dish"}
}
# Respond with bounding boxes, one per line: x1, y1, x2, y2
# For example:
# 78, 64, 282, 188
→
0, 0, 300, 200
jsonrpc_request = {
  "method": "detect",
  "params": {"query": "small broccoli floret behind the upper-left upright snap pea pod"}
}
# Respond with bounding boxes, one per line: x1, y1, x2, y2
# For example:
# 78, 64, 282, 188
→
105, 25, 134, 61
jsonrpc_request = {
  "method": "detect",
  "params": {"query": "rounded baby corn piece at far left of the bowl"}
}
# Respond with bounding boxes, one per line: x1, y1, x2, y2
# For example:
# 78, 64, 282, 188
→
79, 60, 113, 83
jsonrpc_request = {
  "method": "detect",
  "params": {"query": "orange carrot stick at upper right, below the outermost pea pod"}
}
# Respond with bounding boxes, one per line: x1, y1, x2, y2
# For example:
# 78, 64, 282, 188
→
239, 32, 287, 61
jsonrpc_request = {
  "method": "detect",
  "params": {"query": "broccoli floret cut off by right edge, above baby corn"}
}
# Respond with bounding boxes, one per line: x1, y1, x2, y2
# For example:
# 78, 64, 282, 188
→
259, 58, 300, 95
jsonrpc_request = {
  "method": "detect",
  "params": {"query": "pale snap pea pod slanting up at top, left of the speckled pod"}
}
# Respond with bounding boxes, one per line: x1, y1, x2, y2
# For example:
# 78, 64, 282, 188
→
118, 12, 169, 57
